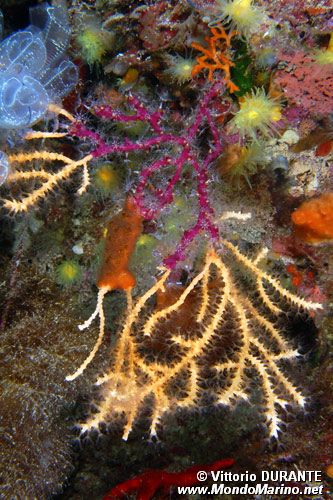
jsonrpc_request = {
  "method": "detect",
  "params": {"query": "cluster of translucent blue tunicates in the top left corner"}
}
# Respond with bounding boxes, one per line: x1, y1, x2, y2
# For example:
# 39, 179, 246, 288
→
0, 3, 78, 129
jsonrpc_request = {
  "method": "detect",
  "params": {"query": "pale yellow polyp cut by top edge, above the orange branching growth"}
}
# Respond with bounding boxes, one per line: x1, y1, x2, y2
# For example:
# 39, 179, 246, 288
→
216, 0, 263, 36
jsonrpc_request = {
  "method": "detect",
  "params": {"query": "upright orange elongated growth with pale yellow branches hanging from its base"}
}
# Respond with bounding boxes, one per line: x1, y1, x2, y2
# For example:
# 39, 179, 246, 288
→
97, 198, 142, 290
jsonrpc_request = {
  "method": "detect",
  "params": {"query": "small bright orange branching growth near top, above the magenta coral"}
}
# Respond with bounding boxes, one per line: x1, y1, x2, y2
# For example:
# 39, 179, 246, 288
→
192, 26, 239, 93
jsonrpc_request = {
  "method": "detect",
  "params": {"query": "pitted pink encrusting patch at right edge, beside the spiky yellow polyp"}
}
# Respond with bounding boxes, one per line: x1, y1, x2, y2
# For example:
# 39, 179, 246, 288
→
274, 51, 333, 115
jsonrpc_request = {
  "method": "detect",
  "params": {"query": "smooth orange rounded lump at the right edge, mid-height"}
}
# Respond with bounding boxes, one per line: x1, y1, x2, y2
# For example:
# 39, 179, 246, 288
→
291, 192, 333, 244
